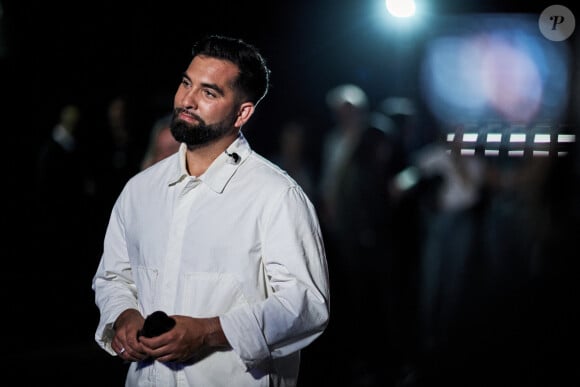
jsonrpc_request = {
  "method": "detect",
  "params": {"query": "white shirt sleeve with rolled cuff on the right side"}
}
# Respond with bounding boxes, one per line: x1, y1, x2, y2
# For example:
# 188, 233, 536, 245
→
220, 186, 330, 368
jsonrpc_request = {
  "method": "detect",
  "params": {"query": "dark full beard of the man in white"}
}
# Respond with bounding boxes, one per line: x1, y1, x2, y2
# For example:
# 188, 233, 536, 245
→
171, 109, 236, 149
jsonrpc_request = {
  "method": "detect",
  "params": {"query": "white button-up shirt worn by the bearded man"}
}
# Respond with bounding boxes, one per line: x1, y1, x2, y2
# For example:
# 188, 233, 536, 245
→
93, 135, 329, 387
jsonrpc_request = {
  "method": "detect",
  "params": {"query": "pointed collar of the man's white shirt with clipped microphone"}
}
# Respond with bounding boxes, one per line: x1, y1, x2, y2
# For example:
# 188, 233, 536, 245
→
168, 132, 252, 193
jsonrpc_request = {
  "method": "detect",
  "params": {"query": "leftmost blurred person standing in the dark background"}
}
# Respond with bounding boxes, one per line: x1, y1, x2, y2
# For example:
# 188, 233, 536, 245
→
31, 102, 99, 345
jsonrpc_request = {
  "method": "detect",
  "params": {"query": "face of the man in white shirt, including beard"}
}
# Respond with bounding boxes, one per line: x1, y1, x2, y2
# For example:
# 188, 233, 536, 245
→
171, 56, 241, 148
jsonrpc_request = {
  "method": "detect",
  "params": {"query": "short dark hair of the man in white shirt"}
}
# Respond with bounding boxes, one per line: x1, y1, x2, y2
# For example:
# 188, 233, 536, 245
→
192, 35, 270, 105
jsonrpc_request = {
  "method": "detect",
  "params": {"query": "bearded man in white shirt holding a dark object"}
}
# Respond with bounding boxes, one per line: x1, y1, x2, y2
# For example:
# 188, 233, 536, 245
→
92, 35, 329, 387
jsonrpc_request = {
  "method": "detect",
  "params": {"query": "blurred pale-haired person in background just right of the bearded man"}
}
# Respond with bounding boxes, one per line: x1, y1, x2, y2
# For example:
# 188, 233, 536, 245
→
318, 84, 394, 386
